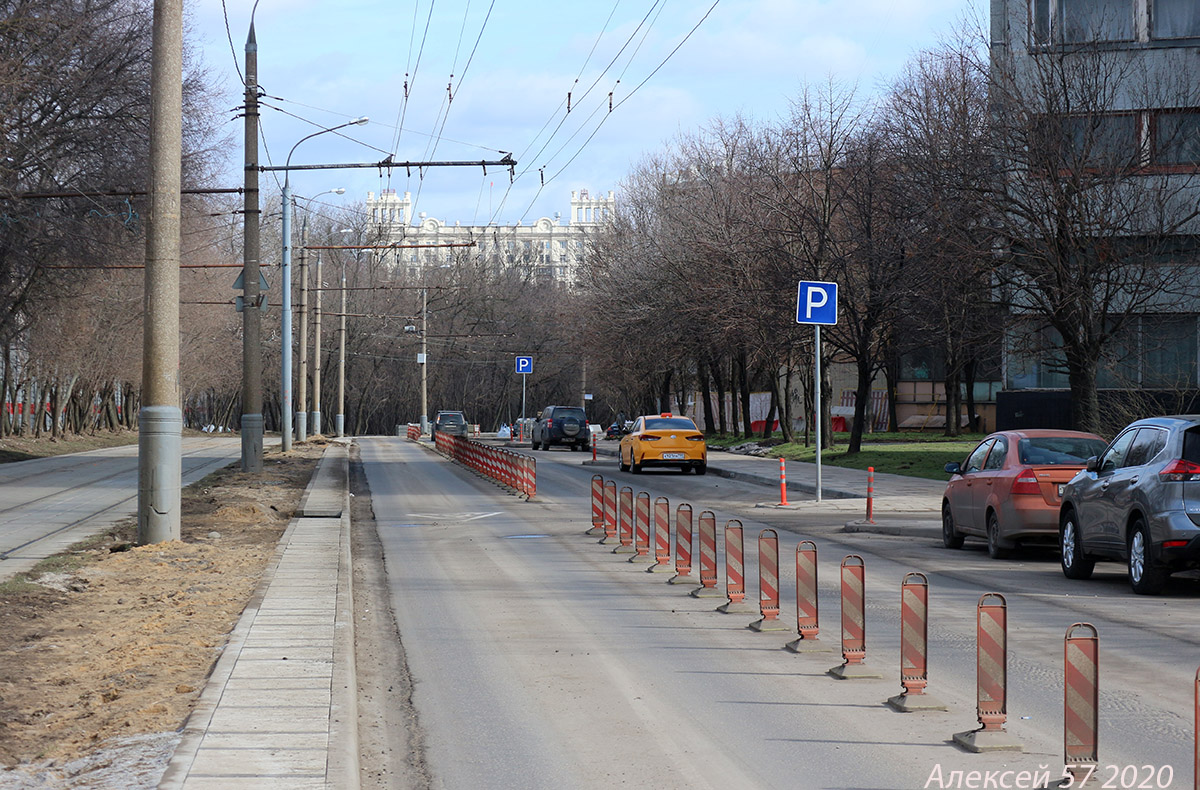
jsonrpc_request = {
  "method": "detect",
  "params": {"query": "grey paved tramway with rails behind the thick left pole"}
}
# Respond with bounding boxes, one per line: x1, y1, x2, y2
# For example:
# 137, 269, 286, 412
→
0, 437, 241, 580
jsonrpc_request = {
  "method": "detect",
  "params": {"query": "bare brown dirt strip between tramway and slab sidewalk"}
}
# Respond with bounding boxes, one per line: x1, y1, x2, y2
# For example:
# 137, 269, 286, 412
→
0, 439, 324, 789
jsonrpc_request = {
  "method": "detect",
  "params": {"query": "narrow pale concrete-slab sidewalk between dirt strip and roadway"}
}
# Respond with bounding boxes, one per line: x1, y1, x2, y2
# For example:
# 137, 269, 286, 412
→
158, 442, 359, 790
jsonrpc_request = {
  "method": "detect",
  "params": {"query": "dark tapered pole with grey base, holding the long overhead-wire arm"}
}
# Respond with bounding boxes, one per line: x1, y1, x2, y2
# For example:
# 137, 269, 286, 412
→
241, 22, 263, 473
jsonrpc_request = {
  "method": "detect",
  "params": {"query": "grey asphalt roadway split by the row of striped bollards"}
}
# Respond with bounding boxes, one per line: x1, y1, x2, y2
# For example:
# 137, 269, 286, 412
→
359, 438, 1200, 789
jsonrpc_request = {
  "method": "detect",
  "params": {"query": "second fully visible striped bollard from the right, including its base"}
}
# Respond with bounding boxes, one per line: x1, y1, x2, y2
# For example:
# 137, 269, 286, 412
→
954, 593, 1022, 752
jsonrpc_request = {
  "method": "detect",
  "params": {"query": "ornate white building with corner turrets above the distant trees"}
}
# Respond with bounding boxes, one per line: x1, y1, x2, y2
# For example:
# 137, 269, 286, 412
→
366, 190, 616, 283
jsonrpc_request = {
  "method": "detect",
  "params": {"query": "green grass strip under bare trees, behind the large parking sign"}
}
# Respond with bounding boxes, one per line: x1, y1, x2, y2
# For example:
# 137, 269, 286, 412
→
708, 433, 984, 480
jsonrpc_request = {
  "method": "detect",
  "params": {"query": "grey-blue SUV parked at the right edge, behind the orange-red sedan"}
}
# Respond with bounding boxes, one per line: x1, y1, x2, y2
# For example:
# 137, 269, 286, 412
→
1058, 414, 1200, 594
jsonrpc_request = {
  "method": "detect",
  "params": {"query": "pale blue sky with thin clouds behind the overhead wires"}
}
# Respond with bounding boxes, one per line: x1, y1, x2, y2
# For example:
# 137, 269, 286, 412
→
185, 0, 985, 225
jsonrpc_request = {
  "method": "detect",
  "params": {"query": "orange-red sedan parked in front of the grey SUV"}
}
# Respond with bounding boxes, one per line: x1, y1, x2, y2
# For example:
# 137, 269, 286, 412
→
942, 430, 1104, 559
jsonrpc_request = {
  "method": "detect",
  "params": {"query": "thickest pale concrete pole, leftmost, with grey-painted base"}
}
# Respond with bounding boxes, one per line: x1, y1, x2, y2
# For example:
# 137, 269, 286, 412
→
138, 0, 184, 545
